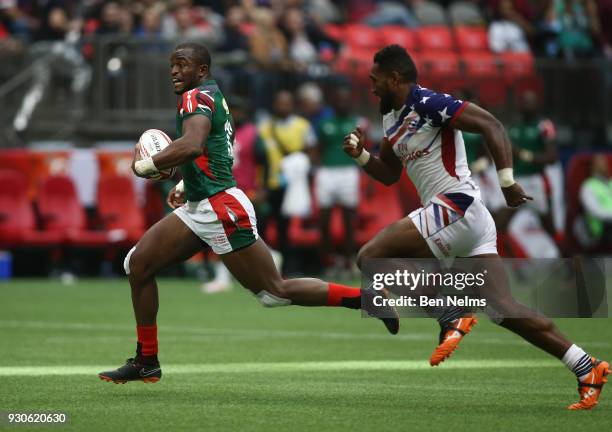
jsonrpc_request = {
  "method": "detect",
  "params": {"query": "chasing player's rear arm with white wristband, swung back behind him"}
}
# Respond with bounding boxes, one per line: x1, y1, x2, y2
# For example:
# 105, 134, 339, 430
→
453, 104, 533, 207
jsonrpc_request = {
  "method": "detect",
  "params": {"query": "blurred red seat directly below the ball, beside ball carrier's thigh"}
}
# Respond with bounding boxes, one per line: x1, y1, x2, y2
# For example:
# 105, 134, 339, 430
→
98, 176, 144, 244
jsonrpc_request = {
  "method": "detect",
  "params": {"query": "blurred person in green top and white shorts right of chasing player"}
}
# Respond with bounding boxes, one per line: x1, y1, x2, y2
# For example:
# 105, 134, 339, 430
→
508, 90, 557, 238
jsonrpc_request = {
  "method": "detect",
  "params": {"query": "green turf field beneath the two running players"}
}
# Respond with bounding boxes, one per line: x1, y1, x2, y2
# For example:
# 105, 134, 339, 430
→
0, 280, 612, 431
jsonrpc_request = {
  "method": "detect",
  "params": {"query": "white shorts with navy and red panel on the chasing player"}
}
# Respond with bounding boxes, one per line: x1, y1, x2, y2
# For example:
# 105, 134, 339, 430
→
408, 192, 497, 259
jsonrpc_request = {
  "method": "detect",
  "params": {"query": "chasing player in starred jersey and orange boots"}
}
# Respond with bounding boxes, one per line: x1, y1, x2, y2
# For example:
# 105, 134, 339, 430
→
343, 45, 610, 410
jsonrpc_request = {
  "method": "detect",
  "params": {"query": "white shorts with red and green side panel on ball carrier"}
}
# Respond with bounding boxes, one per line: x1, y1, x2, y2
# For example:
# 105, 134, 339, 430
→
174, 187, 259, 255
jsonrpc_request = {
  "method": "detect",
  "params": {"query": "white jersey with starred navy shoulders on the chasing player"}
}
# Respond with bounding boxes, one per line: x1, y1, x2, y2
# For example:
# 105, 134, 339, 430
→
383, 85, 480, 205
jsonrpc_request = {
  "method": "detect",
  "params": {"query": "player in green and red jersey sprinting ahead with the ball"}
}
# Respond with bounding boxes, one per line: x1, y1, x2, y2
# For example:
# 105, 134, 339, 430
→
99, 43, 399, 383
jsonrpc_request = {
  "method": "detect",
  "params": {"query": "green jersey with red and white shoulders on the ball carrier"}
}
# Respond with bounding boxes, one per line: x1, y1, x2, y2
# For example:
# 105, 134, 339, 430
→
176, 79, 236, 201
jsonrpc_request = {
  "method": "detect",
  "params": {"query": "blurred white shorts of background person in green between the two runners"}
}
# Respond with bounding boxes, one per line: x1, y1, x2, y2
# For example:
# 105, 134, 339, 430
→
315, 166, 359, 208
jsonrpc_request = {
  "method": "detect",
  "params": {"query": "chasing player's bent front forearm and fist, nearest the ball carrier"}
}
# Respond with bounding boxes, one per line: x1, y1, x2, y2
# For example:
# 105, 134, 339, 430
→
343, 128, 402, 186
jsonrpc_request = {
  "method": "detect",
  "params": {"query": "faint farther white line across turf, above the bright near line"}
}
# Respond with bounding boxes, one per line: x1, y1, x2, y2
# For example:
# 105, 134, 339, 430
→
0, 320, 611, 348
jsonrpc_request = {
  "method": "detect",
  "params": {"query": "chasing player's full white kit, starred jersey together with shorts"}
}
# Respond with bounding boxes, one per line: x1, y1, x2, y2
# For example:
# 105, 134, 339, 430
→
383, 85, 497, 259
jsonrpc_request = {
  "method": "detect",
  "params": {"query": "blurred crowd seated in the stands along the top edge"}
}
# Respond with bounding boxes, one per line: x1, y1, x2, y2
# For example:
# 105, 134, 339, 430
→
0, 0, 612, 59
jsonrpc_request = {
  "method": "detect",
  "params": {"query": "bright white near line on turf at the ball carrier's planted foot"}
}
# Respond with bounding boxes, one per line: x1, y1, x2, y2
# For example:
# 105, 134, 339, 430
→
0, 360, 559, 376
